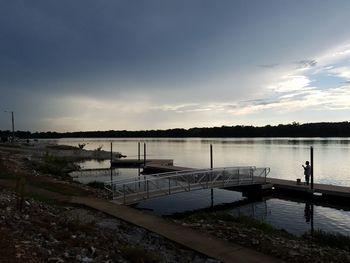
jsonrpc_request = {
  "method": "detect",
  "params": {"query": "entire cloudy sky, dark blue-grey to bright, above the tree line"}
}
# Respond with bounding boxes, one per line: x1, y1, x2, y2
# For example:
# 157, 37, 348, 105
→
0, 0, 350, 132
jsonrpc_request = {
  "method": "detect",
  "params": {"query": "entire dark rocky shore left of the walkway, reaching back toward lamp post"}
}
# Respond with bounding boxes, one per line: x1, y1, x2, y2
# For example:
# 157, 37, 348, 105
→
0, 145, 218, 263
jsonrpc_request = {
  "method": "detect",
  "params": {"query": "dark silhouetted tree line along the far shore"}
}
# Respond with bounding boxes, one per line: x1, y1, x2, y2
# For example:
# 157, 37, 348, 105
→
0, 122, 350, 139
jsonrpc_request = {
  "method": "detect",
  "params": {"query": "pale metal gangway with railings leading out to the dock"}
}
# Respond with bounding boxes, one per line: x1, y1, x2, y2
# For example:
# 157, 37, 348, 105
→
104, 166, 270, 204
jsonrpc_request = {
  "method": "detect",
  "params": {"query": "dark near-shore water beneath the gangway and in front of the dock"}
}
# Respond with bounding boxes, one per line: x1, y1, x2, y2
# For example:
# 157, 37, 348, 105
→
137, 189, 350, 236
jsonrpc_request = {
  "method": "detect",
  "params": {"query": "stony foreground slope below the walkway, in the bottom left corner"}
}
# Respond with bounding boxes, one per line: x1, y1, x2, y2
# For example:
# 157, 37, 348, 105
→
0, 188, 217, 263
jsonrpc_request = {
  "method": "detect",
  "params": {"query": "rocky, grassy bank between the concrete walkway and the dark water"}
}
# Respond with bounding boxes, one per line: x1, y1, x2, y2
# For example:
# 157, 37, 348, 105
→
173, 212, 350, 263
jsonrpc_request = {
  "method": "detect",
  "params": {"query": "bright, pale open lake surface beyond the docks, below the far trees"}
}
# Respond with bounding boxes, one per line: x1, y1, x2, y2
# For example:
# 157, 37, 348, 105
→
53, 138, 350, 186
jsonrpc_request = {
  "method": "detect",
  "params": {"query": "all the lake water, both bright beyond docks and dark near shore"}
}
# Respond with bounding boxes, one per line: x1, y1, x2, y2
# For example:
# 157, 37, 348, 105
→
45, 138, 350, 235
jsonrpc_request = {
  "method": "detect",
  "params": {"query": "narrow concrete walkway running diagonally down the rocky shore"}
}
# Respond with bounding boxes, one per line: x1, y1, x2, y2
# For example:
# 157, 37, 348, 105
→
70, 197, 284, 263
